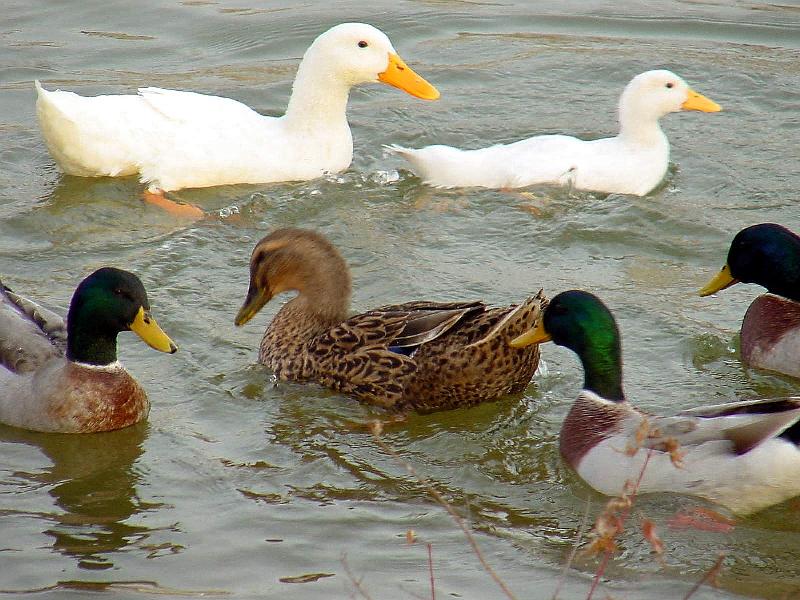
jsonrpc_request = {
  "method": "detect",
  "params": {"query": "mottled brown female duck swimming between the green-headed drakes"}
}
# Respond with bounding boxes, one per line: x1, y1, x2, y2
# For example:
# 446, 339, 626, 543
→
236, 228, 546, 412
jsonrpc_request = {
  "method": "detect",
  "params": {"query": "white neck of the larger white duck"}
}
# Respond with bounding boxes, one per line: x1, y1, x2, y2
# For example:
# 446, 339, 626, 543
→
284, 56, 351, 128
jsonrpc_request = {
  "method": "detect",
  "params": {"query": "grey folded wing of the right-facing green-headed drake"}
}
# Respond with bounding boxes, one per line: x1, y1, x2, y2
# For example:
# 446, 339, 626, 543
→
0, 282, 67, 374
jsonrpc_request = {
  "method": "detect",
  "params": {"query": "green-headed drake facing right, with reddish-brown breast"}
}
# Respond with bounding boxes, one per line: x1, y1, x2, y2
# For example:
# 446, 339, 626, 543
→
0, 267, 177, 433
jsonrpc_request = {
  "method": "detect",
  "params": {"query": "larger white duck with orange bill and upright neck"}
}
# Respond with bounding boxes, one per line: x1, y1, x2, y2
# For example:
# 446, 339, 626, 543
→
36, 23, 439, 216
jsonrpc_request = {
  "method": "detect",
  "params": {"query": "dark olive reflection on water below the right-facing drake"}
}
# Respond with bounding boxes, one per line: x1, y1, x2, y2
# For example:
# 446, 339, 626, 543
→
0, 423, 162, 569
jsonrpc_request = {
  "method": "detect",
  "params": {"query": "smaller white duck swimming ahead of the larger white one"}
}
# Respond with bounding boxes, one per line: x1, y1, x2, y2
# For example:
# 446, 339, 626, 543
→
387, 70, 721, 196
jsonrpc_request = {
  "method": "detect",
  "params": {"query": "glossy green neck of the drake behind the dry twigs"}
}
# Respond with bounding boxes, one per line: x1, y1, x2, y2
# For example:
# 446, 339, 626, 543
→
576, 330, 625, 402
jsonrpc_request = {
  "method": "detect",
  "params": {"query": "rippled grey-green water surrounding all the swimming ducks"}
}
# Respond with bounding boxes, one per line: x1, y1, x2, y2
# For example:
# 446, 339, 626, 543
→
0, 0, 800, 600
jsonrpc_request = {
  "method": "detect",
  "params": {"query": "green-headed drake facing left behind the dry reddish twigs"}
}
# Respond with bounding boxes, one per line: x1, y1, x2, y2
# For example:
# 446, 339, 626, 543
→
511, 290, 800, 514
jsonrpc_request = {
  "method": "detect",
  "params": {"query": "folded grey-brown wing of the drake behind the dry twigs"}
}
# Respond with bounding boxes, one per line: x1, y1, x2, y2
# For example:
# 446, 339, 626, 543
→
649, 397, 800, 454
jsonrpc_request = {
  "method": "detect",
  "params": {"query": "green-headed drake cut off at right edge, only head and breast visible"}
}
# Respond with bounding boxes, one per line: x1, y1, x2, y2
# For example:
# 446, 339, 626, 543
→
700, 223, 800, 377
